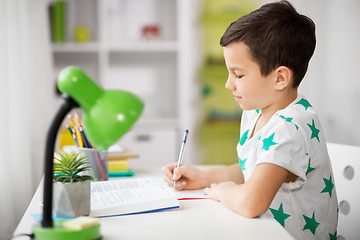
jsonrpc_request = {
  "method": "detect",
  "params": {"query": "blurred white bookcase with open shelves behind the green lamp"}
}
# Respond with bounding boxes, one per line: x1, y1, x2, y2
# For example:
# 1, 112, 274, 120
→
49, 0, 200, 166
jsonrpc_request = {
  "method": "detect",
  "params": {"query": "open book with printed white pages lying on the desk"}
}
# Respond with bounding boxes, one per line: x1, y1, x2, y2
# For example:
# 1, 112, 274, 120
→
90, 178, 180, 217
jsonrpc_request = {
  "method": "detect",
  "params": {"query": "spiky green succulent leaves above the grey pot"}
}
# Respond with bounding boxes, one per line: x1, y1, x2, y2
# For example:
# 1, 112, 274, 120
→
54, 152, 93, 183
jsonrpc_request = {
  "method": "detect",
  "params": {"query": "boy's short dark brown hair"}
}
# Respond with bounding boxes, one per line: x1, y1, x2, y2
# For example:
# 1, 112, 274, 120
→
220, 1, 316, 87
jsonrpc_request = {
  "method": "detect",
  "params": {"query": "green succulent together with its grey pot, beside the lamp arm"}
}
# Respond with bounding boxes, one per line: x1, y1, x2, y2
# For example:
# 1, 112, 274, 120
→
53, 151, 92, 218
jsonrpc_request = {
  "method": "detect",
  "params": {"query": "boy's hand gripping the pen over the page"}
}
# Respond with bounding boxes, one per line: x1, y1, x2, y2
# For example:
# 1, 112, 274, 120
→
161, 163, 205, 190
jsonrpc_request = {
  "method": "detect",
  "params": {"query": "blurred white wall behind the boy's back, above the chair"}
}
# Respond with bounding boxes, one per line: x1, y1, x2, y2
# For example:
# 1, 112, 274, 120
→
266, 0, 360, 145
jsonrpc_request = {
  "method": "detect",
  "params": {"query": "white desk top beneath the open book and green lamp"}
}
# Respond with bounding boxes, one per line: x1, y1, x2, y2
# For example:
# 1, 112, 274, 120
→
14, 169, 293, 240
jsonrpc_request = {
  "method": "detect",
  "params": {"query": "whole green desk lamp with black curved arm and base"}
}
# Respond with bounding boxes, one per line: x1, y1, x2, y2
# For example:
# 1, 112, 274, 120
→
33, 67, 144, 240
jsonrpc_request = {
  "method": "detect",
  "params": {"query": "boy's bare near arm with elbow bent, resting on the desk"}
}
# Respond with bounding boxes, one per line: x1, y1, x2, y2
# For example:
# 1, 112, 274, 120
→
204, 163, 291, 218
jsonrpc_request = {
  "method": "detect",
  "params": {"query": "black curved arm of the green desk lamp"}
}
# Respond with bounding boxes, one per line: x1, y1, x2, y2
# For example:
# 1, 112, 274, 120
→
41, 94, 79, 227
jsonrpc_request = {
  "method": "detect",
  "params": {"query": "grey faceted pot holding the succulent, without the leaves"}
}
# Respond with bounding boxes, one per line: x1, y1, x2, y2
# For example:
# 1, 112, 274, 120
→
53, 181, 91, 218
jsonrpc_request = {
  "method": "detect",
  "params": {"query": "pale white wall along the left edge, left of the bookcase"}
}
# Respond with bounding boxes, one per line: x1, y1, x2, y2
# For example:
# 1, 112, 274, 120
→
0, 0, 56, 239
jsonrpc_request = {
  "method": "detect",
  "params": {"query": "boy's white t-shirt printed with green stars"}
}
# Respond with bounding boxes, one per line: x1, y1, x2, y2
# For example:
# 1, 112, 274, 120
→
237, 95, 338, 240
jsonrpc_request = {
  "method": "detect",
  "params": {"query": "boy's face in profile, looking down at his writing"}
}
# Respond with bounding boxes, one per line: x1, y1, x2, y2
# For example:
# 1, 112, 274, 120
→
224, 42, 276, 110
